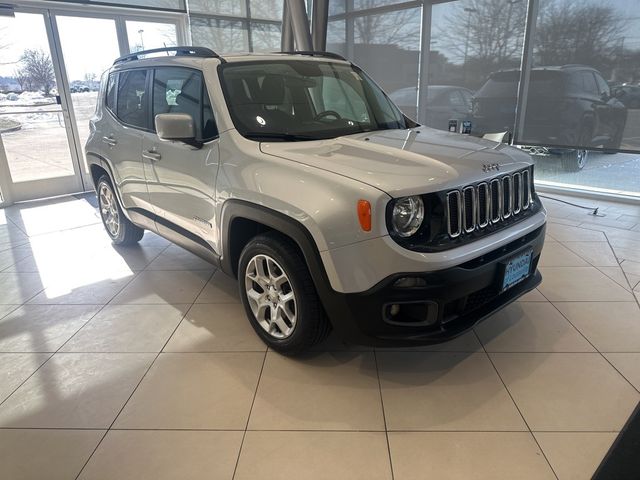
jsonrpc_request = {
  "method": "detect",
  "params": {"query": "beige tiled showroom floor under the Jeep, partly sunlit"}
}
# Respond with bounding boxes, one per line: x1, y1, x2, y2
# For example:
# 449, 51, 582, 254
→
0, 193, 640, 480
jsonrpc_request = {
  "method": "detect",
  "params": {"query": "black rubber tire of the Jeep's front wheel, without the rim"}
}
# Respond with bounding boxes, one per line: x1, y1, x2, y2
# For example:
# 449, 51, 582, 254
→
238, 232, 331, 355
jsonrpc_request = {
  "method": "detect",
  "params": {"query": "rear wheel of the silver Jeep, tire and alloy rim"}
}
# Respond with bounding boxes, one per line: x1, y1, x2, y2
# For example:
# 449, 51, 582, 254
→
96, 175, 144, 245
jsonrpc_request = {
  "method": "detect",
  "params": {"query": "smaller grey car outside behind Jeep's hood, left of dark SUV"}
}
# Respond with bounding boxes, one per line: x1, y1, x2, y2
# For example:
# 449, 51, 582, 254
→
389, 85, 473, 130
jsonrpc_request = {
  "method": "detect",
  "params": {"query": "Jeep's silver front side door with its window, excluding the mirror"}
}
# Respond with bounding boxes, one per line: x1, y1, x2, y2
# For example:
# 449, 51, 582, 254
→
142, 67, 219, 246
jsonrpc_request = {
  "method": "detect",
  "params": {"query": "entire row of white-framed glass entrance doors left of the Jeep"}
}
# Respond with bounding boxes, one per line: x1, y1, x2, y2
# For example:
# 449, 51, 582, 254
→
0, 5, 187, 206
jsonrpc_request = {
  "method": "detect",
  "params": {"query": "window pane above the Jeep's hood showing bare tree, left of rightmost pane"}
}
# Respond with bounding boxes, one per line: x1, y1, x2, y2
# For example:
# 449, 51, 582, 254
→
423, 0, 527, 135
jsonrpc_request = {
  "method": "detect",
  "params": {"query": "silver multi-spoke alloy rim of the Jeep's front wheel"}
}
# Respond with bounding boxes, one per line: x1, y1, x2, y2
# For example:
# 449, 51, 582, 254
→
244, 254, 297, 340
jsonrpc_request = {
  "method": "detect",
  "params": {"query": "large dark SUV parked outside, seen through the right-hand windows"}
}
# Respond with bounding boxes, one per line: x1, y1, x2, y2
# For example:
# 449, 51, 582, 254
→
472, 65, 627, 170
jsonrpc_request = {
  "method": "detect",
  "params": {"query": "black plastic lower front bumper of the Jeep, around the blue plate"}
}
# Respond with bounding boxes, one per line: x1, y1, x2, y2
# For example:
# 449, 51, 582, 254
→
323, 225, 545, 346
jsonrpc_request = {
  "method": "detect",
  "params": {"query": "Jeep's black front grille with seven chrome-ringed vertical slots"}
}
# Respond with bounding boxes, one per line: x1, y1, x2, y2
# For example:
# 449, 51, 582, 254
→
446, 169, 533, 238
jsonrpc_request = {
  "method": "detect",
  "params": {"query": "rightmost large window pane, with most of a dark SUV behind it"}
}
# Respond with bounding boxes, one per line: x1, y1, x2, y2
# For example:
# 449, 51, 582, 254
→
516, 0, 640, 197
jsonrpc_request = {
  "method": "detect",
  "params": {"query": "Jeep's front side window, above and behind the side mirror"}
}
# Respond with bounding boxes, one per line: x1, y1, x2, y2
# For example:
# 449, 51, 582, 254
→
153, 67, 218, 141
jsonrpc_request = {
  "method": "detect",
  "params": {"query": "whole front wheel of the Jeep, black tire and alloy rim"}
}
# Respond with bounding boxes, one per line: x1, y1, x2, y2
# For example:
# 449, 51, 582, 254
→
238, 232, 330, 355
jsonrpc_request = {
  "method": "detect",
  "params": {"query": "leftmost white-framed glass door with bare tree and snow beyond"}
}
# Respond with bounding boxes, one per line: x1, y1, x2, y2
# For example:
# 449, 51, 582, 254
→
0, 12, 84, 201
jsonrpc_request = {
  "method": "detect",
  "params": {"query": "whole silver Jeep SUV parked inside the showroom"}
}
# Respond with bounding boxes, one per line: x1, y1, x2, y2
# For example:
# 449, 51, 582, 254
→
86, 47, 546, 354
